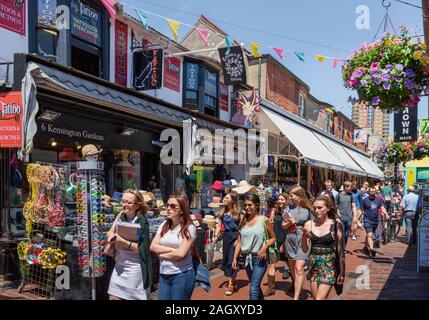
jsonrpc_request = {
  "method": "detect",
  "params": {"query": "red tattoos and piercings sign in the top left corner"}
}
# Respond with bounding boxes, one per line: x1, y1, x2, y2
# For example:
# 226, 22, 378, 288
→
0, 0, 25, 36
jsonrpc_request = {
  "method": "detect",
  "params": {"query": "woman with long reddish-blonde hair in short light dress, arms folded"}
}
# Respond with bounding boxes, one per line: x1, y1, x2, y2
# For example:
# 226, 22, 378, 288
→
282, 185, 313, 300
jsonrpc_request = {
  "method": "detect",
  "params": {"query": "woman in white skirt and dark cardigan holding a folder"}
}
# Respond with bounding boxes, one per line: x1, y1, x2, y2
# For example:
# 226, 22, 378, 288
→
107, 189, 152, 300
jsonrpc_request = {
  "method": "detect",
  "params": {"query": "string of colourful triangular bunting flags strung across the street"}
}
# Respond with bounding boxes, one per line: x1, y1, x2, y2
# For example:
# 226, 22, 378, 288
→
119, 0, 345, 69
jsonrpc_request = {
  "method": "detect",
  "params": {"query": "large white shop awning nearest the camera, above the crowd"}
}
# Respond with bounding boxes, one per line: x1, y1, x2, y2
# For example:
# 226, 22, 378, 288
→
262, 107, 348, 171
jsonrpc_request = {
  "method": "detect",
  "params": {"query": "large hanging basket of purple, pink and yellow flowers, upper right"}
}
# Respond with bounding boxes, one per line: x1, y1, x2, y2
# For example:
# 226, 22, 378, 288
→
342, 28, 429, 111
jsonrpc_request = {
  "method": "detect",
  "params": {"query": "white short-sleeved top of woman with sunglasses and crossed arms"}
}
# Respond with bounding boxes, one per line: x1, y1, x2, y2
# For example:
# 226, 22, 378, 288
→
156, 221, 197, 274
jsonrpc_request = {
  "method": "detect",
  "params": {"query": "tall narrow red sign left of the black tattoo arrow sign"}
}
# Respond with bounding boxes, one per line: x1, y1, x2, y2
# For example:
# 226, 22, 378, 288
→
115, 20, 128, 87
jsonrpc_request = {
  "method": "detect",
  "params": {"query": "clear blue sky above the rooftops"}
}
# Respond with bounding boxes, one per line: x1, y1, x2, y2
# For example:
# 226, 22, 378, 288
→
120, 0, 422, 127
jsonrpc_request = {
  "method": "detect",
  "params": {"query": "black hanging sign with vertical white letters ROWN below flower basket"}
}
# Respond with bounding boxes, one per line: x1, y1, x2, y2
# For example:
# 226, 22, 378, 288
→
393, 106, 417, 142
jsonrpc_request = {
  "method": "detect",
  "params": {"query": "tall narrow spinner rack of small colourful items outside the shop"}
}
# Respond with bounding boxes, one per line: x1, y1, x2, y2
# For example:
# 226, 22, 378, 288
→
76, 161, 107, 300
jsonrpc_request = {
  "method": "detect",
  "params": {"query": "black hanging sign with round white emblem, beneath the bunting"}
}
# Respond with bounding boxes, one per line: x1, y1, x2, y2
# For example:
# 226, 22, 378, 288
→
219, 46, 247, 85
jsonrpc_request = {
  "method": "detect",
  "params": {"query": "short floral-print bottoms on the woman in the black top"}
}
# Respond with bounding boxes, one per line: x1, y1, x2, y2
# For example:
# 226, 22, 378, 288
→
307, 253, 335, 285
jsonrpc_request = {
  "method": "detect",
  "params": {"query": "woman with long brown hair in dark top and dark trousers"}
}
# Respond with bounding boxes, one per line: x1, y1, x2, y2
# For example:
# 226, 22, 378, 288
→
214, 192, 244, 296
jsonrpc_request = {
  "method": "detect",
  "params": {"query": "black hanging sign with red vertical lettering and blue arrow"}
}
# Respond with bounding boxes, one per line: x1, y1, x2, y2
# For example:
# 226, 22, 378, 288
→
133, 49, 163, 90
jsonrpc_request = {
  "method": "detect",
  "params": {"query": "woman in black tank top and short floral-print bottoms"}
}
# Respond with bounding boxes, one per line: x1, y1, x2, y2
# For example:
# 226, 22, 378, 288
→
301, 196, 345, 300
